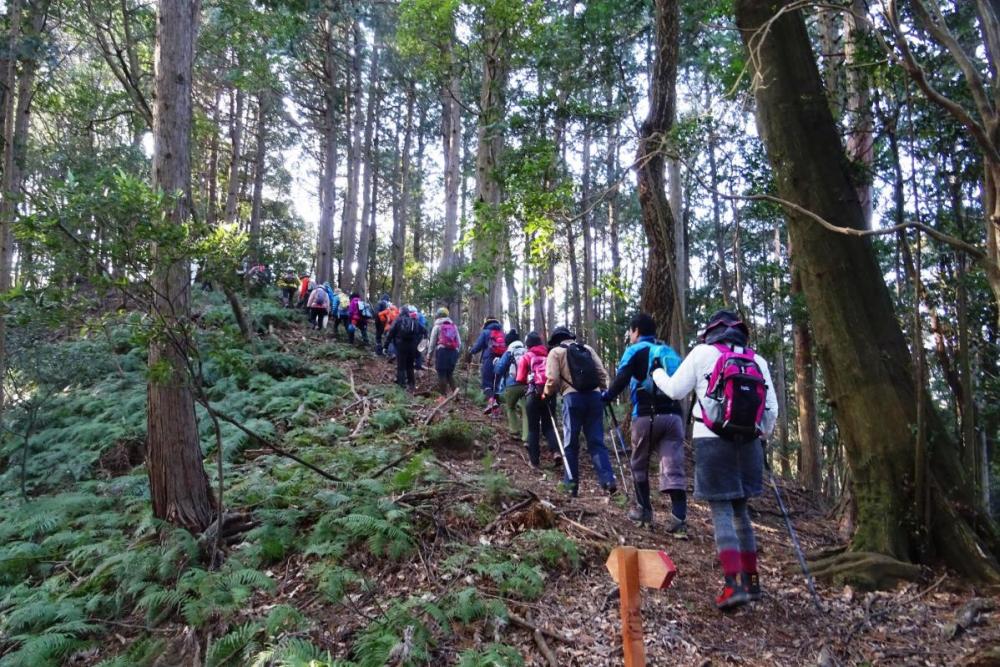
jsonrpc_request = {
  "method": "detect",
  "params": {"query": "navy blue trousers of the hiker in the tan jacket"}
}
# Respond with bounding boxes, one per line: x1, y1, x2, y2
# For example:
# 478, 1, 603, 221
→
563, 391, 615, 489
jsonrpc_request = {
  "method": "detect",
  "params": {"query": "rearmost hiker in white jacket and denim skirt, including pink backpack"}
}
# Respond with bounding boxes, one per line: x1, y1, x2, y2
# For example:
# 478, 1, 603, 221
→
653, 310, 778, 610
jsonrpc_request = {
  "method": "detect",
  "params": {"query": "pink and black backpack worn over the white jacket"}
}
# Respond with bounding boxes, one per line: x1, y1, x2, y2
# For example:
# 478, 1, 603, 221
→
698, 343, 767, 442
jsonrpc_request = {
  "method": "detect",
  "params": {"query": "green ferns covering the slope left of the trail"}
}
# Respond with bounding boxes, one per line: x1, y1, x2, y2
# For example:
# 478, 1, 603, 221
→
0, 295, 579, 667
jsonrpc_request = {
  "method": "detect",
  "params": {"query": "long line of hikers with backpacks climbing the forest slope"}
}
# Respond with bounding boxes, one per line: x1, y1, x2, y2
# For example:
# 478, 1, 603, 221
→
279, 272, 778, 610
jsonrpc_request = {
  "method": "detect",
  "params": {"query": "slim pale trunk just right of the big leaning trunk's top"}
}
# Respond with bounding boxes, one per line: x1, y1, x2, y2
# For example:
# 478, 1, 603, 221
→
844, 0, 875, 228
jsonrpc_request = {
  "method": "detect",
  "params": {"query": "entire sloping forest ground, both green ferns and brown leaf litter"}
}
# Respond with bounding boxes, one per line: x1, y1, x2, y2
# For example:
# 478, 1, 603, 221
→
0, 297, 1000, 667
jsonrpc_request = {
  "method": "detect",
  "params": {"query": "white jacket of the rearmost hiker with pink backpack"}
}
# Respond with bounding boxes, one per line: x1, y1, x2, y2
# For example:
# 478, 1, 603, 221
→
653, 344, 778, 438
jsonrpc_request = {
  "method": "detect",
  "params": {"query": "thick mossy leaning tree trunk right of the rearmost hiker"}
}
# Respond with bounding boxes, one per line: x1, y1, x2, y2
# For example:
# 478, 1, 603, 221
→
735, 0, 1000, 586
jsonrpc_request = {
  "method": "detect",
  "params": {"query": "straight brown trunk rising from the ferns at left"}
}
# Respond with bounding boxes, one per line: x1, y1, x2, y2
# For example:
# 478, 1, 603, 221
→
146, 0, 215, 532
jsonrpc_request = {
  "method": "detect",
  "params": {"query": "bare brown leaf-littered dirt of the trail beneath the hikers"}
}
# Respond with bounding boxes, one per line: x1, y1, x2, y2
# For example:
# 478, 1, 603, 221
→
270, 320, 1000, 666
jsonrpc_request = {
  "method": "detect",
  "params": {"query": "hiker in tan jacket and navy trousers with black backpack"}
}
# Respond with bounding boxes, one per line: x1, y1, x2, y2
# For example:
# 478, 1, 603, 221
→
542, 326, 618, 497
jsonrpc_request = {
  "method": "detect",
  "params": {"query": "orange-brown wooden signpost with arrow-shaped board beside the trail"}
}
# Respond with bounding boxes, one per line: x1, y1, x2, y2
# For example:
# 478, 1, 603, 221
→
607, 547, 677, 667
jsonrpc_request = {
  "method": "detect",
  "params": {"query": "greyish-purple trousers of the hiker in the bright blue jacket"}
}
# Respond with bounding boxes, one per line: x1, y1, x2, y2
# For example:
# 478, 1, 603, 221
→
630, 413, 687, 491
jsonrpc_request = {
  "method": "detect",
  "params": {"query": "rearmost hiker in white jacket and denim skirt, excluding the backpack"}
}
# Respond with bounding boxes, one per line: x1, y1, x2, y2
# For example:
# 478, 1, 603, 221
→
653, 310, 778, 610
